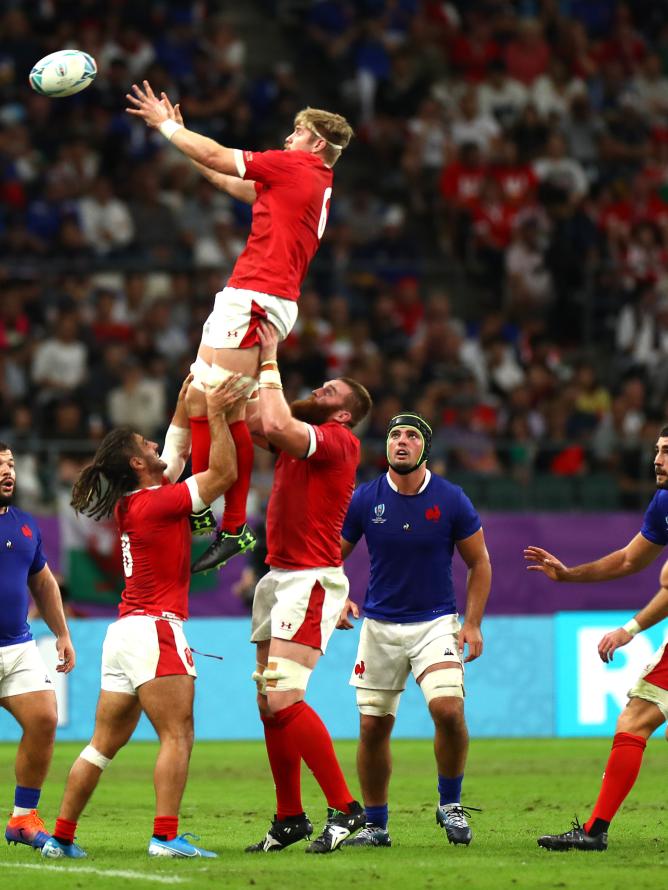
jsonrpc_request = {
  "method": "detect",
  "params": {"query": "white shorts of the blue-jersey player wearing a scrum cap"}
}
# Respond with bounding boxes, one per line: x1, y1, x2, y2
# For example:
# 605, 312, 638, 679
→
350, 615, 463, 692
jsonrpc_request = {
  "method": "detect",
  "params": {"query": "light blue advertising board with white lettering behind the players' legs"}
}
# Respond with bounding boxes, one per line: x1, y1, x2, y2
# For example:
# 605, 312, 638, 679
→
0, 611, 664, 741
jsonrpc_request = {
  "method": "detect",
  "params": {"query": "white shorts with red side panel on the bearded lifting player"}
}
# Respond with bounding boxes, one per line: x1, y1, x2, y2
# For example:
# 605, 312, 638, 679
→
251, 566, 348, 653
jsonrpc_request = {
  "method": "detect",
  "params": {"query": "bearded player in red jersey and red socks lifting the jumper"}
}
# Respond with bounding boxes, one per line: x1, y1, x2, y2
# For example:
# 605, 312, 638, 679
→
246, 324, 371, 853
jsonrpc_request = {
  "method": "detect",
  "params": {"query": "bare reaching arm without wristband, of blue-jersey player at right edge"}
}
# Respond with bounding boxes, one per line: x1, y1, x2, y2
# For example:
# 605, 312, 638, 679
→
524, 533, 663, 583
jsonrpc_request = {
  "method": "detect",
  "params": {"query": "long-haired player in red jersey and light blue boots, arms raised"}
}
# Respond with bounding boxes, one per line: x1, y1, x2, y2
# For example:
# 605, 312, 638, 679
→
42, 375, 242, 859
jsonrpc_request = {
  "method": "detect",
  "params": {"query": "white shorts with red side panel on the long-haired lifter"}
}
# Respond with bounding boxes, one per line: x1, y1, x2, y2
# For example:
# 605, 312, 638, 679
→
101, 615, 197, 695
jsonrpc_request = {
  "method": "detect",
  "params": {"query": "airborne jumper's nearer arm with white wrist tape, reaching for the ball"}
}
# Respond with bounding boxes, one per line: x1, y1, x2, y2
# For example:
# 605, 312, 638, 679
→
125, 80, 239, 176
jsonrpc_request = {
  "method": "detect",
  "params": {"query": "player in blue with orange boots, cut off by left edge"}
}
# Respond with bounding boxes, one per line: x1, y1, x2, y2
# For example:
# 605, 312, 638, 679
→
0, 442, 75, 847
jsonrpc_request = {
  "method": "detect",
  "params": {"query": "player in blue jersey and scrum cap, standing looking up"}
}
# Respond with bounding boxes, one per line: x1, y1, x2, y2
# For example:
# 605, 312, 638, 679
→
338, 412, 492, 847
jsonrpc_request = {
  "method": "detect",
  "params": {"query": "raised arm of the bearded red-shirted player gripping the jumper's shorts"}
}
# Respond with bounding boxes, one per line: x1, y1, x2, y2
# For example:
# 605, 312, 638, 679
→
258, 322, 311, 458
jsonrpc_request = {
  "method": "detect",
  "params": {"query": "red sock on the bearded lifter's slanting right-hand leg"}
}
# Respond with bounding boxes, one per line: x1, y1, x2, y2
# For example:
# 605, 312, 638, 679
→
276, 701, 353, 813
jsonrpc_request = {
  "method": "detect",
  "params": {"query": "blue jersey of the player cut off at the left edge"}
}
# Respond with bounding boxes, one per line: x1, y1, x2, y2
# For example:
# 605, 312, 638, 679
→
0, 507, 46, 646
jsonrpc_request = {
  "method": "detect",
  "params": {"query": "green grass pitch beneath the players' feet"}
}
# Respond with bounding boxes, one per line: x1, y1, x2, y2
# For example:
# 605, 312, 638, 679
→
0, 739, 668, 890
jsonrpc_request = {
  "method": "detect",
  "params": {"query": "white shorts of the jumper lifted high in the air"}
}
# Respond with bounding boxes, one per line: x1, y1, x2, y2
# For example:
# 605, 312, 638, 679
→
202, 287, 297, 349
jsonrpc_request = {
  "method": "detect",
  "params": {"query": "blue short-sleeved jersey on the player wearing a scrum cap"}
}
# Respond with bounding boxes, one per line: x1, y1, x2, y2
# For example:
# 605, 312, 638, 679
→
341, 473, 481, 623
